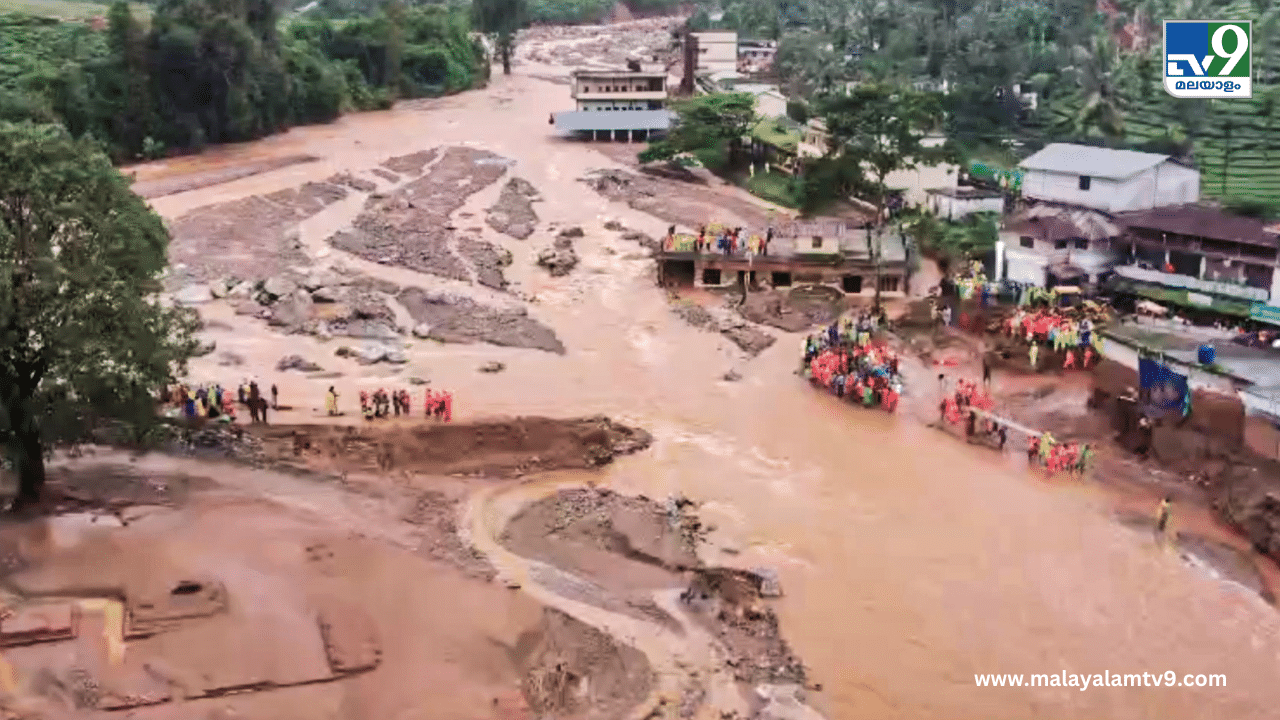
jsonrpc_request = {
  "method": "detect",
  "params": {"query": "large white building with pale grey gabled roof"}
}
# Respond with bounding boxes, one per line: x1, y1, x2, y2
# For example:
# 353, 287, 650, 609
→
1018, 142, 1201, 213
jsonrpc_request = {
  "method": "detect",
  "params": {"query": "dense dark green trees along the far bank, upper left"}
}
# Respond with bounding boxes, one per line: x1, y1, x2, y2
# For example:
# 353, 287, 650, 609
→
0, 0, 489, 161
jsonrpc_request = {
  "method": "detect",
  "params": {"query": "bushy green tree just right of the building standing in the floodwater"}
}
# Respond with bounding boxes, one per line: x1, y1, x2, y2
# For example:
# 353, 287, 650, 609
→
640, 92, 756, 163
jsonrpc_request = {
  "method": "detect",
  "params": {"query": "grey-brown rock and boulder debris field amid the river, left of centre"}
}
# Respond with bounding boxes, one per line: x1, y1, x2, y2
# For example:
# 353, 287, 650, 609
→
166, 147, 564, 353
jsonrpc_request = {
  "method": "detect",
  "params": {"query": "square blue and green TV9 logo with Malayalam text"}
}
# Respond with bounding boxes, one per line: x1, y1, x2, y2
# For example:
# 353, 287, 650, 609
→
1165, 20, 1253, 99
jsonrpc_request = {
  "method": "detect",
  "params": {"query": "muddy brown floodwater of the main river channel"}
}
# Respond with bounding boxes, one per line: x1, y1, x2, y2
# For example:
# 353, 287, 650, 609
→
132, 51, 1280, 720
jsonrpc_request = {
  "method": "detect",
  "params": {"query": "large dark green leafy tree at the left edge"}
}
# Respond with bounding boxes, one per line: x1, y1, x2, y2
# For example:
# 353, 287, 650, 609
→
0, 122, 195, 507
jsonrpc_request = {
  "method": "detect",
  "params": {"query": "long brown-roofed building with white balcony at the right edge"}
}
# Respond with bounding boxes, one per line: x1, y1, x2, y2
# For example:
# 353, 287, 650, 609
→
1110, 204, 1280, 316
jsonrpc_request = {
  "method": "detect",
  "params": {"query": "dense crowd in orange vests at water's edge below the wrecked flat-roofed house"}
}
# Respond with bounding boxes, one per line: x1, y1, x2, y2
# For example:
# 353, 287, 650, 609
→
804, 314, 902, 413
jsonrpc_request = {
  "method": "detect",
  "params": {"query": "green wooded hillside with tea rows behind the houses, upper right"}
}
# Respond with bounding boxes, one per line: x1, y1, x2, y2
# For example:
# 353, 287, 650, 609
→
691, 0, 1280, 202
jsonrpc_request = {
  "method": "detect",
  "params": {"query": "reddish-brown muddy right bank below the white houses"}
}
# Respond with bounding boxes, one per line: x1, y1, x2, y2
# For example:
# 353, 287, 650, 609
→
900, 299, 1280, 602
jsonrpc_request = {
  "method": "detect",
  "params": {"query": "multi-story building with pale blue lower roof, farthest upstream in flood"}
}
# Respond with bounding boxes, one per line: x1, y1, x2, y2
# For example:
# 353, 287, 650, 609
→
553, 70, 672, 141
